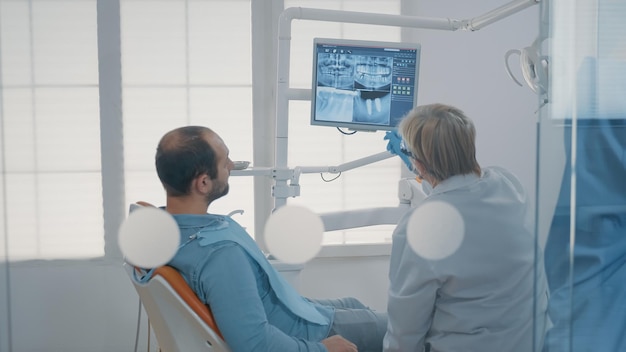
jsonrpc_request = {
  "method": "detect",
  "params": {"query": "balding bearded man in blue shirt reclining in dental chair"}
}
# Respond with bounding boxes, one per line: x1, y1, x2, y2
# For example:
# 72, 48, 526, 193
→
155, 126, 387, 352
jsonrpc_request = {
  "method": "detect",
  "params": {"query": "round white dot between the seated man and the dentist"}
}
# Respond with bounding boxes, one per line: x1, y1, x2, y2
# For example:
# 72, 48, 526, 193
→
264, 205, 324, 264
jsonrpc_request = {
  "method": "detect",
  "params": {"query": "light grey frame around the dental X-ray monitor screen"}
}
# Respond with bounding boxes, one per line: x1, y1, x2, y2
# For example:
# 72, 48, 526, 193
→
310, 38, 421, 132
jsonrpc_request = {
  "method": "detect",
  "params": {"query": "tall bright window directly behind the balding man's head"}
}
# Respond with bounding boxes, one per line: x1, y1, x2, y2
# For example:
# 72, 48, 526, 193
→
121, 0, 254, 228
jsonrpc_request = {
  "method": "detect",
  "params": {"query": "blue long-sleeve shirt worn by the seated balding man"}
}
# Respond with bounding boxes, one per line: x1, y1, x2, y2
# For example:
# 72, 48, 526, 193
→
169, 214, 334, 352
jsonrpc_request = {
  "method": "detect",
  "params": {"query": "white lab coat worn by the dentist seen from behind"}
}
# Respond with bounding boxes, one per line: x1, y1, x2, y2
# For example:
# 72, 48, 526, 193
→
384, 168, 547, 352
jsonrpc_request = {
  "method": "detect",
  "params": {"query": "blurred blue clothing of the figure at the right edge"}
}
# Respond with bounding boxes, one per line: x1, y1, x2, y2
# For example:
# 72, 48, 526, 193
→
543, 57, 626, 352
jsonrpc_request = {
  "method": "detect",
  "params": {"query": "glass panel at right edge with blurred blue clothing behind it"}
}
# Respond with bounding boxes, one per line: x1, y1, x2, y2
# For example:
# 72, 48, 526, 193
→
537, 0, 626, 352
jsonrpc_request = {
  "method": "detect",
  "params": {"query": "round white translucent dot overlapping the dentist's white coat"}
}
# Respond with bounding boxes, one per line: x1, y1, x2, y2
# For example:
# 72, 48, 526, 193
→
407, 201, 465, 260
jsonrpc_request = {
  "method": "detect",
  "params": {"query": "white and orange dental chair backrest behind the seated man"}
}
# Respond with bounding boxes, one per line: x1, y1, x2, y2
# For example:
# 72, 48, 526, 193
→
125, 264, 230, 352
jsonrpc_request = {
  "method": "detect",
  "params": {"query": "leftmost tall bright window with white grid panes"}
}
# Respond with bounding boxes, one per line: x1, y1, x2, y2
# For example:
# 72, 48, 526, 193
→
0, 0, 104, 261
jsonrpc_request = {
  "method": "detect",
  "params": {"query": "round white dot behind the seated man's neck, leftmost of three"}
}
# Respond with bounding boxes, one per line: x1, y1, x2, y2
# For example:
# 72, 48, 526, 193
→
118, 207, 180, 268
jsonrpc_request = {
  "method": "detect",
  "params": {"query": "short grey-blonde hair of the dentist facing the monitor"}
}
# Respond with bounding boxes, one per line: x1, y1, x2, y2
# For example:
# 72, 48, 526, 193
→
398, 104, 481, 182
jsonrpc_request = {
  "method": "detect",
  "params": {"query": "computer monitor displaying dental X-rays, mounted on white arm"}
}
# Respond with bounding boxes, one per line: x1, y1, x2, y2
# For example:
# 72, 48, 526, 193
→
311, 38, 421, 131
